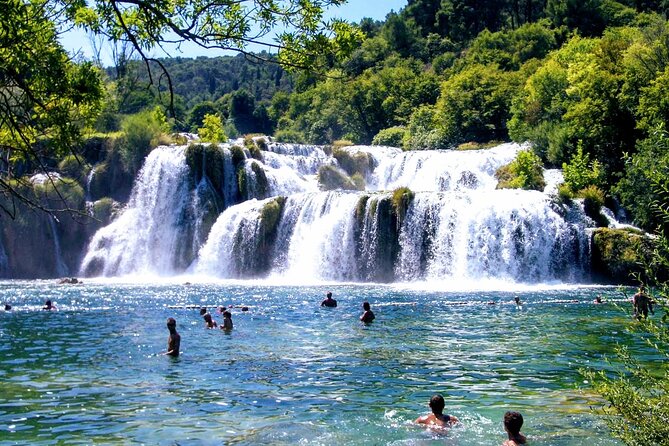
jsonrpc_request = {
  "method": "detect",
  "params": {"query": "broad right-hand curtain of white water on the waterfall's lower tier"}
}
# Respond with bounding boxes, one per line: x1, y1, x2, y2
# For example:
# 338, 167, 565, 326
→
397, 190, 587, 282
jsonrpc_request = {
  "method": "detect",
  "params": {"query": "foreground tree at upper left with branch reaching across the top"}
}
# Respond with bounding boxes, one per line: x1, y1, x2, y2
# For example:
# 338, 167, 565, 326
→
0, 0, 362, 215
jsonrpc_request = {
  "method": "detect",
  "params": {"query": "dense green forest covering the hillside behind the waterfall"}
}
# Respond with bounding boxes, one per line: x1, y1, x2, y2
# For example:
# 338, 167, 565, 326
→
92, 0, 669, 235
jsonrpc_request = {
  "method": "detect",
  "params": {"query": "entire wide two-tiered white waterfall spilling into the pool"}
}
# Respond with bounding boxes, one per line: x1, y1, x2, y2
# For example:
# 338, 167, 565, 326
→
82, 143, 591, 283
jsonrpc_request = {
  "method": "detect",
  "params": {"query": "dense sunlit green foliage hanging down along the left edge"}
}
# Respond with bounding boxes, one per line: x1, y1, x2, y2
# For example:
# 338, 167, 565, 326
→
0, 0, 103, 218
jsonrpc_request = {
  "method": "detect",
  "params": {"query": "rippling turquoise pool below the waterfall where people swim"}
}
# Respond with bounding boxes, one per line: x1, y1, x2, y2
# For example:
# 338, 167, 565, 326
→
0, 282, 642, 446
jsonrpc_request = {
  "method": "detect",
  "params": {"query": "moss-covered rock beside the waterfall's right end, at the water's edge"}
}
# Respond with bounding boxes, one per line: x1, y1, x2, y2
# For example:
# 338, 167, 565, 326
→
591, 228, 653, 284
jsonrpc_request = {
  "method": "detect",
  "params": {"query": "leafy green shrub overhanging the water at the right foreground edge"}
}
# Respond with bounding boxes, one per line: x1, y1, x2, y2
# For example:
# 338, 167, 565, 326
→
584, 177, 669, 446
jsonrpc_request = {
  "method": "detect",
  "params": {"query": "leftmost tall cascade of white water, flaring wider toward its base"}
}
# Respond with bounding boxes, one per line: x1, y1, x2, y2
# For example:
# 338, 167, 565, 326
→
81, 147, 189, 276
